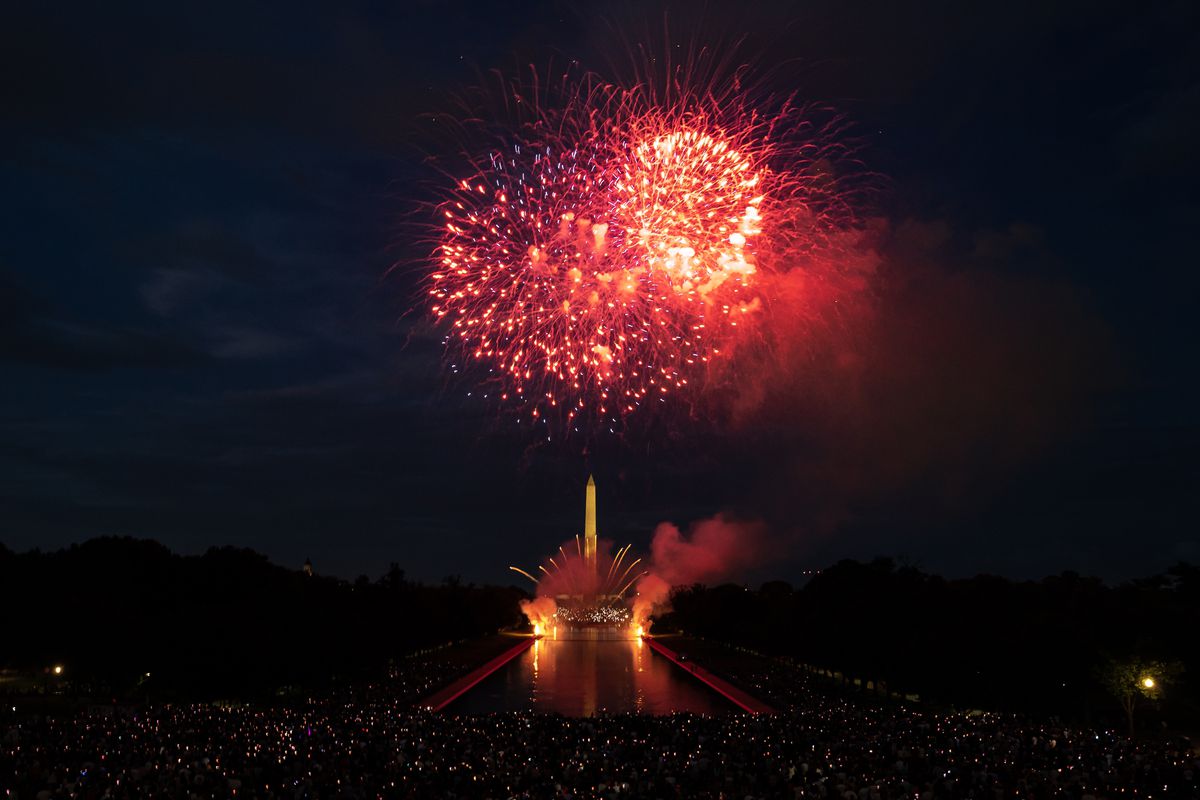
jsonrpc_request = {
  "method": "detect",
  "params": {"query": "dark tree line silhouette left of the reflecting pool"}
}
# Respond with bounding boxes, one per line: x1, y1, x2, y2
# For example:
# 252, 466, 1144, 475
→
0, 537, 524, 699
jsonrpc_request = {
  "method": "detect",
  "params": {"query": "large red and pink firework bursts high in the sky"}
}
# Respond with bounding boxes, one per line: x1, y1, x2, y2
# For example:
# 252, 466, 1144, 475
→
428, 68, 859, 426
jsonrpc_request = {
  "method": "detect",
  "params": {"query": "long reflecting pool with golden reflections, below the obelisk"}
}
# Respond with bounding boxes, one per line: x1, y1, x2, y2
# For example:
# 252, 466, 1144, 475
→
446, 626, 733, 716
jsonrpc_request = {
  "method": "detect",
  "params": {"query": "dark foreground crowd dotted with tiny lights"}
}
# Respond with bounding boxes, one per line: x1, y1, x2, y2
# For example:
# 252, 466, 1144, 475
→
0, 688, 1200, 800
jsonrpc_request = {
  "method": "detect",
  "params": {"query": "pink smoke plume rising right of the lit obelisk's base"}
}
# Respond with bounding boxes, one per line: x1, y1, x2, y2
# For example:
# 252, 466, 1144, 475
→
634, 515, 770, 627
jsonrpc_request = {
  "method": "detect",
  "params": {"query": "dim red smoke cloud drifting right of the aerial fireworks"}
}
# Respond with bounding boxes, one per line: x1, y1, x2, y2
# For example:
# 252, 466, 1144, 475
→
696, 215, 1123, 566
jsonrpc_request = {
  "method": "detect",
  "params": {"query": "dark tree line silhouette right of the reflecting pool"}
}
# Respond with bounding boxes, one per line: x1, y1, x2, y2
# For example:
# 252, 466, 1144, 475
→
655, 559, 1200, 724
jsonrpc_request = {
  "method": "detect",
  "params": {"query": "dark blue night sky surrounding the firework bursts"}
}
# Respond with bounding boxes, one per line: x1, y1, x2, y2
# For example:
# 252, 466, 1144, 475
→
0, 0, 1200, 582
